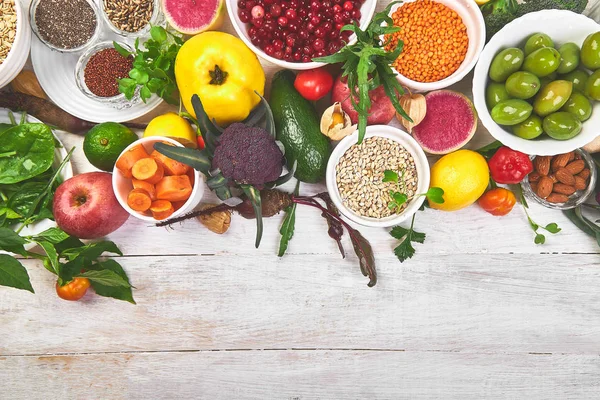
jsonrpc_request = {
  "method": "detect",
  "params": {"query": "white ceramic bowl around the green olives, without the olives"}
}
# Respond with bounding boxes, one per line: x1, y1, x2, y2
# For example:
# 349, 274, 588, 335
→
473, 10, 600, 156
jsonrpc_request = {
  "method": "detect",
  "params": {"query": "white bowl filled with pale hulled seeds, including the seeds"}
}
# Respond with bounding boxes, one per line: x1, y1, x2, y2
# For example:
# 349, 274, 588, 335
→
326, 125, 429, 227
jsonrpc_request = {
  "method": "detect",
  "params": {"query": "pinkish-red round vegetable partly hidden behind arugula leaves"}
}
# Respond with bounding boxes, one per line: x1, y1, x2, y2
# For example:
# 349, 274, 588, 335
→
331, 76, 396, 125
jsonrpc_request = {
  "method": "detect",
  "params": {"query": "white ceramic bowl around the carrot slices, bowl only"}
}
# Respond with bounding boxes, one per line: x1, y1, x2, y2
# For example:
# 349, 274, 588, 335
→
112, 136, 204, 222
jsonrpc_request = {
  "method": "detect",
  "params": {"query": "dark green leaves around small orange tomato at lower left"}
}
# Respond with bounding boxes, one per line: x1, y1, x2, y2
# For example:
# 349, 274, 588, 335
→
0, 228, 135, 304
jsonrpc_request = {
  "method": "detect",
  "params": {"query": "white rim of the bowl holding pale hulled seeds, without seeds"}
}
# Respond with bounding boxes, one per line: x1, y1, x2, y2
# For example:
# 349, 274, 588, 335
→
326, 125, 430, 228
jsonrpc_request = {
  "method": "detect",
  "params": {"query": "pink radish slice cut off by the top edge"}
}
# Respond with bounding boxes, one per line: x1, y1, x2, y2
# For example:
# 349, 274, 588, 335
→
162, 0, 225, 35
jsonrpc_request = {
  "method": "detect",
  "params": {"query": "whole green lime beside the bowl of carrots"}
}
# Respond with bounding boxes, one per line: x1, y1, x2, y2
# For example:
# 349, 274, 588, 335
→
83, 122, 138, 171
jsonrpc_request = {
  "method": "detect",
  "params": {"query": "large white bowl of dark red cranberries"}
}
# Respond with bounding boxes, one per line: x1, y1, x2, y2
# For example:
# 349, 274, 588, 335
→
226, 0, 377, 70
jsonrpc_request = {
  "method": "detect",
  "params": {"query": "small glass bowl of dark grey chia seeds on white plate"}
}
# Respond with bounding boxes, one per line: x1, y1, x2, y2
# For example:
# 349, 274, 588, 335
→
29, 0, 101, 53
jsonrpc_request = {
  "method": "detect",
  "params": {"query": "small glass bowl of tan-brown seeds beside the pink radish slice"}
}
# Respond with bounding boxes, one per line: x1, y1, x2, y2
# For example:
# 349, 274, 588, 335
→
100, 0, 165, 38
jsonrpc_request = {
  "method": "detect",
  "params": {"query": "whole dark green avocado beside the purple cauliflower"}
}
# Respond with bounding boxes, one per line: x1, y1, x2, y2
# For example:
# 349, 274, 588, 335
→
270, 70, 331, 183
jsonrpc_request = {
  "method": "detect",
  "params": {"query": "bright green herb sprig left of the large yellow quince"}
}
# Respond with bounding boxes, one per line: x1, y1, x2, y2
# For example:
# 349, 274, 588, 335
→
113, 26, 183, 105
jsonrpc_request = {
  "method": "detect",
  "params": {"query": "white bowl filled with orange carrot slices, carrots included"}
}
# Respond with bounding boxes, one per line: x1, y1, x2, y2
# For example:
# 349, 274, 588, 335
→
112, 136, 204, 222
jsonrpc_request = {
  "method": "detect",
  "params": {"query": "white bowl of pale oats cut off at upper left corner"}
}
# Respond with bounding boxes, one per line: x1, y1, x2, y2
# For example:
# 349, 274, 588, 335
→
0, 0, 31, 88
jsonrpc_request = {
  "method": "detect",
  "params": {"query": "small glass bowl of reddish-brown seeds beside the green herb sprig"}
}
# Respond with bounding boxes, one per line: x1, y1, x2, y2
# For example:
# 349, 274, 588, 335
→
75, 41, 140, 109
